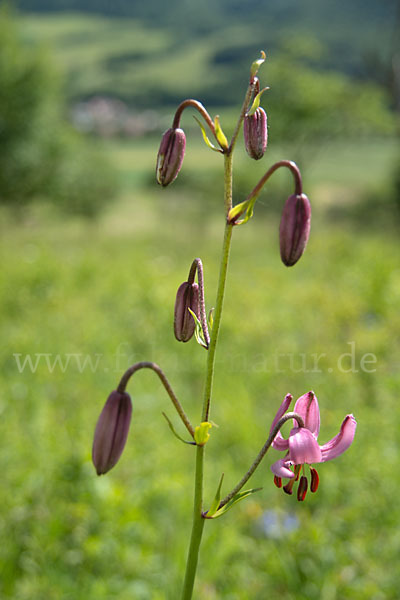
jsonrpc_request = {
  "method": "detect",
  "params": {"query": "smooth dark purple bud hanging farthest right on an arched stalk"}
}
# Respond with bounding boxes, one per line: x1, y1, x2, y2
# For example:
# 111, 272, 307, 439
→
279, 194, 311, 267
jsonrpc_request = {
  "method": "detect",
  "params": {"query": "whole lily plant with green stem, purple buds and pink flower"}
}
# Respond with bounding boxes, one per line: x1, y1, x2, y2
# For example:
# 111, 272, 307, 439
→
92, 52, 356, 600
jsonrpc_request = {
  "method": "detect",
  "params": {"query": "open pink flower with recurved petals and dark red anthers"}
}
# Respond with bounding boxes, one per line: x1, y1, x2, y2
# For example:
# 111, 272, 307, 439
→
270, 392, 357, 501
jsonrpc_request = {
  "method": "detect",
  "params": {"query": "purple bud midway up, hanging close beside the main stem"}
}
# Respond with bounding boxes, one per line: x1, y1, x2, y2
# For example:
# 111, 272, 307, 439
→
174, 281, 200, 342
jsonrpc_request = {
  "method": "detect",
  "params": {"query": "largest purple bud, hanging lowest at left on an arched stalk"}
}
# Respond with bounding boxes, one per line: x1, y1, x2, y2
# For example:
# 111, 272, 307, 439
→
92, 391, 132, 475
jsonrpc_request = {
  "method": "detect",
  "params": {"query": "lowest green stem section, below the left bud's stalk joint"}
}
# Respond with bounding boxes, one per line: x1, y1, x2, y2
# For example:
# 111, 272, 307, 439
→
182, 446, 205, 600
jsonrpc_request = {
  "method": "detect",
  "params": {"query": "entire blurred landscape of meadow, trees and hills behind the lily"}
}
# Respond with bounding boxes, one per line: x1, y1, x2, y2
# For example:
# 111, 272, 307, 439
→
0, 0, 400, 600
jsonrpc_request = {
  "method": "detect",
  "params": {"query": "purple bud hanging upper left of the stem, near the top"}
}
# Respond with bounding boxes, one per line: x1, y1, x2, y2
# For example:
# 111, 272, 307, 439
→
156, 128, 186, 187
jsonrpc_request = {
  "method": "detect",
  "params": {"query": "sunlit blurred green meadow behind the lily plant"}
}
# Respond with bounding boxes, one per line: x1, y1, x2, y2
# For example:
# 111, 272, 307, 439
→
0, 132, 400, 600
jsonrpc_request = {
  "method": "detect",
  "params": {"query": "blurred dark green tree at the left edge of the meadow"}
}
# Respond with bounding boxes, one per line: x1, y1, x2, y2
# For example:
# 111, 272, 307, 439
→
0, 7, 116, 215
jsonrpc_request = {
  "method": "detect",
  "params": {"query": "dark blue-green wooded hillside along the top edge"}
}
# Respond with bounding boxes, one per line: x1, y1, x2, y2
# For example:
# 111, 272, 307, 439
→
16, 0, 399, 77
